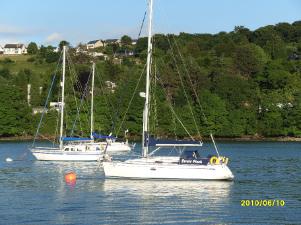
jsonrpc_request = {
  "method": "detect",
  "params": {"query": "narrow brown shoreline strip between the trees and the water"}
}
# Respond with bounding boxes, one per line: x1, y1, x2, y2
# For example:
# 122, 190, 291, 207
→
0, 136, 301, 142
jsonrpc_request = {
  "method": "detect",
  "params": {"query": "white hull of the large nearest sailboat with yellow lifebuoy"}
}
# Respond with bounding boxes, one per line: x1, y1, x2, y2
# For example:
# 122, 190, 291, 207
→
103, 158, 234, 180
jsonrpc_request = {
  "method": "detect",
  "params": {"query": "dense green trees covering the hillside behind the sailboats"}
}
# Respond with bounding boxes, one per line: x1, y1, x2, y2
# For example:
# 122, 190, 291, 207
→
0, 21, 301, 141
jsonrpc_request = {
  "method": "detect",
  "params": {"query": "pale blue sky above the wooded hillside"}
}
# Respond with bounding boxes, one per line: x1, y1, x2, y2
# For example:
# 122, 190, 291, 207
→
0, 0, 301, 46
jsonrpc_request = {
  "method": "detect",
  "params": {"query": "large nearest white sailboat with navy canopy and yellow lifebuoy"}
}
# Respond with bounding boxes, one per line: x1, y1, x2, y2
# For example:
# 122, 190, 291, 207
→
103, 0, 234, 180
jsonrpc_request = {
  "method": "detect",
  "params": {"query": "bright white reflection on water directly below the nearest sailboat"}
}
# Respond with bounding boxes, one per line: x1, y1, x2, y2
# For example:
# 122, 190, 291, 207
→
103, 179, 233, 202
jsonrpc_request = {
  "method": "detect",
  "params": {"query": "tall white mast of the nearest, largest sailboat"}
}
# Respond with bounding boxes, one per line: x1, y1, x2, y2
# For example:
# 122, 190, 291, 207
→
142, 0, 153, 157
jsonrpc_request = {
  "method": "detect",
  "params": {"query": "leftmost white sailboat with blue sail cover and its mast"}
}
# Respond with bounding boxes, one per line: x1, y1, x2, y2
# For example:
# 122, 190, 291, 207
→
30, 46, 104, 161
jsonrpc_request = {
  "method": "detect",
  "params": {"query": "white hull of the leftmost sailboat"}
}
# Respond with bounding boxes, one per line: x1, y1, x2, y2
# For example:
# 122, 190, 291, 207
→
31, 149, 103, 161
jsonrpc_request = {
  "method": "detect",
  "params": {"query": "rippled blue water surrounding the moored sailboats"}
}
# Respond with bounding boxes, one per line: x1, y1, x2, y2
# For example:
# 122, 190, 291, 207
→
0, 142, 301, 225
